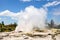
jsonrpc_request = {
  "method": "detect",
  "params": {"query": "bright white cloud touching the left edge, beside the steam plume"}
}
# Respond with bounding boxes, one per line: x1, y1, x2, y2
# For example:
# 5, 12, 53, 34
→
0, 10, 19, 19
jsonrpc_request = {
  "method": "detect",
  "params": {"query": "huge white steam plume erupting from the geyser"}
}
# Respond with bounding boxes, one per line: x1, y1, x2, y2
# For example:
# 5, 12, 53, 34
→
15, 6, 47, 32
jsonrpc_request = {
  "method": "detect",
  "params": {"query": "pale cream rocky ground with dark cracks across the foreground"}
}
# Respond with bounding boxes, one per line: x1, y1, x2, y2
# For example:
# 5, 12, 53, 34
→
0, 31, 60, 40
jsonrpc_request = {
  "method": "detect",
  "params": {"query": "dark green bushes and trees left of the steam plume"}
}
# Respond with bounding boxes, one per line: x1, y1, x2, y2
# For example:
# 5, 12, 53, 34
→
0, 21, 17, 32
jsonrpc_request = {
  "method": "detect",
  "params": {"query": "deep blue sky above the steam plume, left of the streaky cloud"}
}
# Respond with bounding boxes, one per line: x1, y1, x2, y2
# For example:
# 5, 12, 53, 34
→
0, 0, 47, 12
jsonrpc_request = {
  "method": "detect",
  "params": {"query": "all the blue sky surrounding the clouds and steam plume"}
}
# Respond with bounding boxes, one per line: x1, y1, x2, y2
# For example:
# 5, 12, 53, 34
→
0, 0, 60, 24
